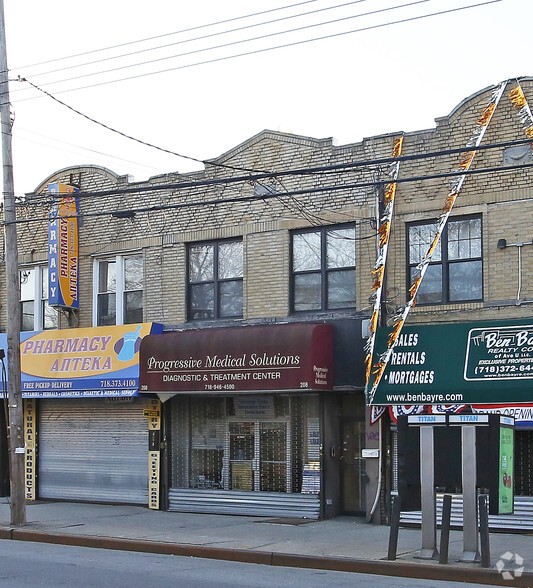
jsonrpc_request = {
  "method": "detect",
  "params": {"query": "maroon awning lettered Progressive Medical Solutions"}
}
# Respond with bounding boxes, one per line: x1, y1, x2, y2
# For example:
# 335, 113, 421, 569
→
140, 324, 333, 393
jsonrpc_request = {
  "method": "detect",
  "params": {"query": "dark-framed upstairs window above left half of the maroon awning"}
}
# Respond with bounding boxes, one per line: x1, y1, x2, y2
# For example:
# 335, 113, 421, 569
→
189, 240, 243, 321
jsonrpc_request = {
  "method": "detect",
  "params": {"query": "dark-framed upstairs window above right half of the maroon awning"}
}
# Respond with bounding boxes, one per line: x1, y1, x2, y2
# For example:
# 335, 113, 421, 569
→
291, 225, 355, 312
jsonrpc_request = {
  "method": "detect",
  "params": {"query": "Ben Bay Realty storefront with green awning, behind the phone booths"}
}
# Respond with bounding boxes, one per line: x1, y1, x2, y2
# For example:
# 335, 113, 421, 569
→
374, 320, 533, 530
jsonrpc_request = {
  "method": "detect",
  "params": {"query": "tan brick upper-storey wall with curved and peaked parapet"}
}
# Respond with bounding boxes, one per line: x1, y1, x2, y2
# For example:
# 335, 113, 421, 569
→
6, 80, 533, 327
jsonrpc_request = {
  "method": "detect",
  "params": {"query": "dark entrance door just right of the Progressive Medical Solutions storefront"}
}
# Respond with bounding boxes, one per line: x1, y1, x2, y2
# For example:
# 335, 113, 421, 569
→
341, 420, 366, 515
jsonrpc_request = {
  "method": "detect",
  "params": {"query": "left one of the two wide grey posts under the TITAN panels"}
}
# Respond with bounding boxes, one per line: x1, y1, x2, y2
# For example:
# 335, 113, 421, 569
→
417, 426, 439, 559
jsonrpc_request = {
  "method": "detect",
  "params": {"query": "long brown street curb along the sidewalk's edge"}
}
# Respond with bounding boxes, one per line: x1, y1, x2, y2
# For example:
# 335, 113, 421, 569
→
0, 528, 533, 587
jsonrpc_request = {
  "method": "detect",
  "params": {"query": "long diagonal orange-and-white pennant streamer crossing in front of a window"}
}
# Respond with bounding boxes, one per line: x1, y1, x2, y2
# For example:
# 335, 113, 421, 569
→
367, 80, 508, 404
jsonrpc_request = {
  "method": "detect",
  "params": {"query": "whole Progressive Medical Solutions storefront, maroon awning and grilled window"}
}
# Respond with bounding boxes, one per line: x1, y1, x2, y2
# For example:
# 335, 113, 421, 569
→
140, 323, 364, 519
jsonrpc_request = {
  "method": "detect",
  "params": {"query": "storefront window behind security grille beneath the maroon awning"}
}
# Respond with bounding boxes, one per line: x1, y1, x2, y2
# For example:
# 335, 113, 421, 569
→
171, 395, 320, 493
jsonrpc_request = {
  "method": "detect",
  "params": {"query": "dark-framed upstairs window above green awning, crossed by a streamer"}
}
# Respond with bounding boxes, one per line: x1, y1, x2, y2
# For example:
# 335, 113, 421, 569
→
408, 216, 483, 304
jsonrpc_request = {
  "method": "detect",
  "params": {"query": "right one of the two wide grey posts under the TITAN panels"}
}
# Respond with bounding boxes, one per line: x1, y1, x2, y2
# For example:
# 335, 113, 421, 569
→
461, 425, 480, 562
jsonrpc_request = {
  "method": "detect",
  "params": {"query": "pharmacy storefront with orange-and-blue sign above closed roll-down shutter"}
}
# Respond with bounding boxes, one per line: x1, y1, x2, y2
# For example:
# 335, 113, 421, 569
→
2, 323, 161, 505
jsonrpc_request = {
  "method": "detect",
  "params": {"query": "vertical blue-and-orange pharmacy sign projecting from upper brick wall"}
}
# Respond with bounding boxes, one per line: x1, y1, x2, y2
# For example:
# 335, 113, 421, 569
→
48, 183, 80, 308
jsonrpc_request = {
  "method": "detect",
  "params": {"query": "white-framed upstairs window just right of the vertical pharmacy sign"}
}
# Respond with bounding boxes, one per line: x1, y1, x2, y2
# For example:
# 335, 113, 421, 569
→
94, 255, 144, 326
